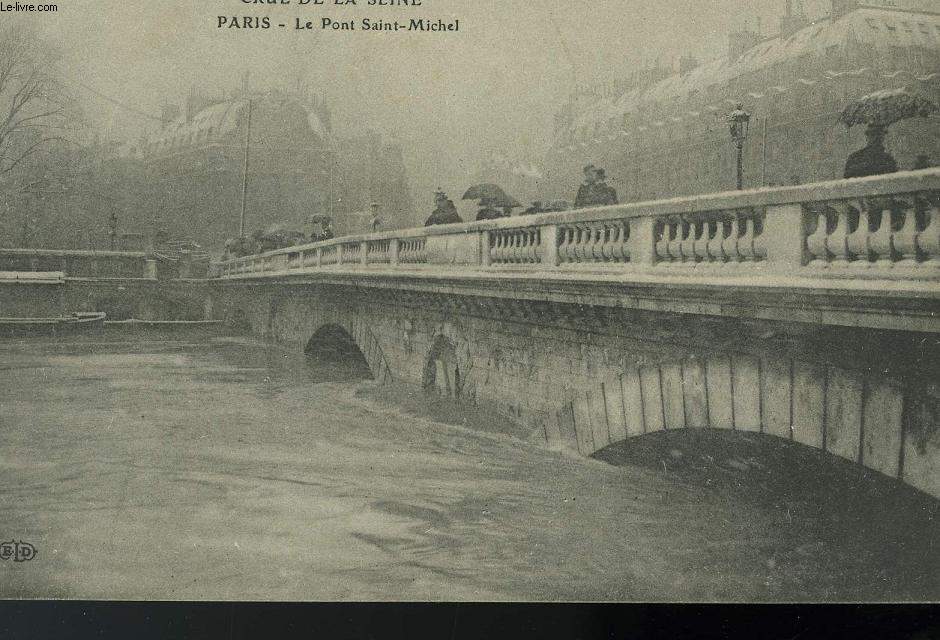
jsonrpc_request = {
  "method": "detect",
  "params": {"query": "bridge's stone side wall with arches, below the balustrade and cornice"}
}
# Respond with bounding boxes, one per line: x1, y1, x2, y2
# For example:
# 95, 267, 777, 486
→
214, 283, 940, 497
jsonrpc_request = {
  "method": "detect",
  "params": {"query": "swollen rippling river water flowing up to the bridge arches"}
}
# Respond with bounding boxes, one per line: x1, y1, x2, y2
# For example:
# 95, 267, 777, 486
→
0, 333, 940, 601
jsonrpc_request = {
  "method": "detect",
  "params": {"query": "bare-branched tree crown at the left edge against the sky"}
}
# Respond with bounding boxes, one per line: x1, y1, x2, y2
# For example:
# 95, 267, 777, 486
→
0, 25, 71, 178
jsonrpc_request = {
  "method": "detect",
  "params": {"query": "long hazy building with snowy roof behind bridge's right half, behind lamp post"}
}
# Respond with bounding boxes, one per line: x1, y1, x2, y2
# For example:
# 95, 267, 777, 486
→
536, 0, 940, 201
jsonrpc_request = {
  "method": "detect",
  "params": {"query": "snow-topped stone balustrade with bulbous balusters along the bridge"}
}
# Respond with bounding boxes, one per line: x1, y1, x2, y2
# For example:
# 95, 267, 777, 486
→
212, 168, 940, 279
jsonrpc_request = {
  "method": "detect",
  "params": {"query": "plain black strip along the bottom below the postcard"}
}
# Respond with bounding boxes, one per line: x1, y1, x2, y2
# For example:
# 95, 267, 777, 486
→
0, 601, 940, 640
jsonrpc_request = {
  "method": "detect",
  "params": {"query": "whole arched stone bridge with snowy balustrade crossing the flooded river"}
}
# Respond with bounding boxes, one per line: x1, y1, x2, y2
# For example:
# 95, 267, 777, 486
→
211, 169, 940, 497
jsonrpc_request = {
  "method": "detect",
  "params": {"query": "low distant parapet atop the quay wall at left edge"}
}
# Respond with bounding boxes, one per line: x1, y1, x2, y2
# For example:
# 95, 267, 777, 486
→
0, 249, 157, 279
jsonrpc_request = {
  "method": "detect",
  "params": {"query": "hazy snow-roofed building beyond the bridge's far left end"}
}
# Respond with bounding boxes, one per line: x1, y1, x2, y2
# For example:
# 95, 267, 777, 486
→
107, 92, 411, 249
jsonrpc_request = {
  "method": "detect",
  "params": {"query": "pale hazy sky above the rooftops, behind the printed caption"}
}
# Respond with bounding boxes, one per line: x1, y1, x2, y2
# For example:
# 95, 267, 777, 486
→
22, 0, 829, 202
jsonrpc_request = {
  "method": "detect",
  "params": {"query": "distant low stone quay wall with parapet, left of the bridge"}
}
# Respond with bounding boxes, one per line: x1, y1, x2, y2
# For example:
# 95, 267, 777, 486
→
0, 249, 211, 320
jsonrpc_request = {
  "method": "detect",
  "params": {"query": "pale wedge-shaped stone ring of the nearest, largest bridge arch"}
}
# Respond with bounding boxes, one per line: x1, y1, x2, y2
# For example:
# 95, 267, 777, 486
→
545, 354, 940, 496
